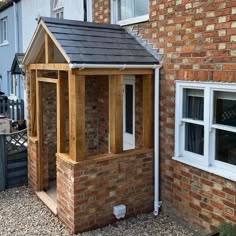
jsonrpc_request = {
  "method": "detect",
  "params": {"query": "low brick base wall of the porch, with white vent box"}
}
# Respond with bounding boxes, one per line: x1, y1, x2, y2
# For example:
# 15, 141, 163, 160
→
57, 150, 153, 232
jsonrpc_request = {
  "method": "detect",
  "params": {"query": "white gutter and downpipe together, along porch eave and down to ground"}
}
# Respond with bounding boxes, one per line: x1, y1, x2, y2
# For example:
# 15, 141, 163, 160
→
69, 63, 162, 216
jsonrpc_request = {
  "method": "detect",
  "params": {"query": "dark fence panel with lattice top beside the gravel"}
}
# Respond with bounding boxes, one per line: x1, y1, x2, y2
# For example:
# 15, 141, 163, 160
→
0, 129, 28, 191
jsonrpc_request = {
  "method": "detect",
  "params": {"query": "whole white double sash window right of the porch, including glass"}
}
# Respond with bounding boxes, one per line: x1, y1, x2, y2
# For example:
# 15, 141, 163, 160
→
174, 81, 236, 181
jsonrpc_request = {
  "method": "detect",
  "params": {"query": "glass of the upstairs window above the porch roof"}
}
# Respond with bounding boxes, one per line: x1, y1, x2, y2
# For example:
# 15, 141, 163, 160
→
118, 0, 149, 20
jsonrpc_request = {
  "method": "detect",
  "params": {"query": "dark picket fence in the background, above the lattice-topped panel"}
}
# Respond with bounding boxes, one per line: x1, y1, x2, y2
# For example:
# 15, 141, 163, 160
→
0, 99, 24, 121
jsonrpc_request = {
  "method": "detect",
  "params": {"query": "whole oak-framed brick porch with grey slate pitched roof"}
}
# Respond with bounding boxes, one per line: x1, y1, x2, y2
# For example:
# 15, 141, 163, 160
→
23, 17, 160, 232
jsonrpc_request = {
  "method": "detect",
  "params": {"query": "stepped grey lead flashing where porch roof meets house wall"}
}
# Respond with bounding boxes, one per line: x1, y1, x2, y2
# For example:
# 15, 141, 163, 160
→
125, 27, 163, 62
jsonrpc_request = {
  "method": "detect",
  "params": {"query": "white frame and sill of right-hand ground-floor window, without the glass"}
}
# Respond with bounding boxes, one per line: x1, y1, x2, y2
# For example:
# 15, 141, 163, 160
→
173, 81, 236, 181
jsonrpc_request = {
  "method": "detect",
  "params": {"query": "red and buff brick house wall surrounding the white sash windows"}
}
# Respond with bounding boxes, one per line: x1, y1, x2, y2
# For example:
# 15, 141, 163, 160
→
93, 0, 236, 231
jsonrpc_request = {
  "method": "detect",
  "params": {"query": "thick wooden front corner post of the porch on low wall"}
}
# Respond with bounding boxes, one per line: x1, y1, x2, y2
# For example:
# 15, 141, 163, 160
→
68, 71, 85, 162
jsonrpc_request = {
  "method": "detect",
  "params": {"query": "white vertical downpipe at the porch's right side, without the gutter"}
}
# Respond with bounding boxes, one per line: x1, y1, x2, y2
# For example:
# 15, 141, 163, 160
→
153, 66, 162, 216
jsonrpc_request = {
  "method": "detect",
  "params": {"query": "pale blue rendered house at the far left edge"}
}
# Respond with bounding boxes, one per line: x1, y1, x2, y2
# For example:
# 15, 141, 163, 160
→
0, 0, 24, 98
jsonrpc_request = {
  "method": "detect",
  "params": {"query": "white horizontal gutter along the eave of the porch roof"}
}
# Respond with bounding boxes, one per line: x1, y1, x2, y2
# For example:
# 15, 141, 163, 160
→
69, 63, 160, 70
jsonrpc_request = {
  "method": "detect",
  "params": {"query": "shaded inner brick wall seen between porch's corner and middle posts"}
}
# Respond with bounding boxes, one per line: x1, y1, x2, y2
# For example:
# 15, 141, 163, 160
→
85, 76, 109, 155
